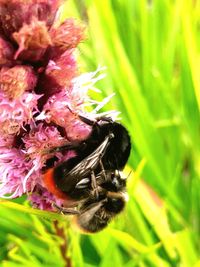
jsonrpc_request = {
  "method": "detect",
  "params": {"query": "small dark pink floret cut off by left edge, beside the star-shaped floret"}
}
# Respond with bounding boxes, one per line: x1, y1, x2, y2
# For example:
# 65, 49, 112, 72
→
0, 37, 14, 66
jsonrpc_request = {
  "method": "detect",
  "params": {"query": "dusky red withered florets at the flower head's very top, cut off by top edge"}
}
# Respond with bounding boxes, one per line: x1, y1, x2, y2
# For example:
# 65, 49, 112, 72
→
0, 0, 63, 38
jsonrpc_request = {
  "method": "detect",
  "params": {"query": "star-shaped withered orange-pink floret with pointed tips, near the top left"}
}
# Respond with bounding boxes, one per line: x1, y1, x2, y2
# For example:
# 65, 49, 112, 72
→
13, 19, 51, 62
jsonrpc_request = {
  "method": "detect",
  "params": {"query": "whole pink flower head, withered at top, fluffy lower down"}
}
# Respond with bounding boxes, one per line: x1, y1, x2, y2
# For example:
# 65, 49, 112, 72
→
0, 0, 104, 209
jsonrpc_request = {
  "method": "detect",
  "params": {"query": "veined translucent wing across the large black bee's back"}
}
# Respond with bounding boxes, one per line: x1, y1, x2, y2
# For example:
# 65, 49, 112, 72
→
66, 135, 112, 178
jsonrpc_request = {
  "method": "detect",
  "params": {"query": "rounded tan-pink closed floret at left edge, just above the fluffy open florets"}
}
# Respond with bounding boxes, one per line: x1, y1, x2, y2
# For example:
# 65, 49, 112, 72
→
0, 65, 37, 99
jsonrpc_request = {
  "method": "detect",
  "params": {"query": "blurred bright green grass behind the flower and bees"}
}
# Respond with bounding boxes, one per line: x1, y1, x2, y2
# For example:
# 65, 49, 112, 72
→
0, 0, 200, 267
